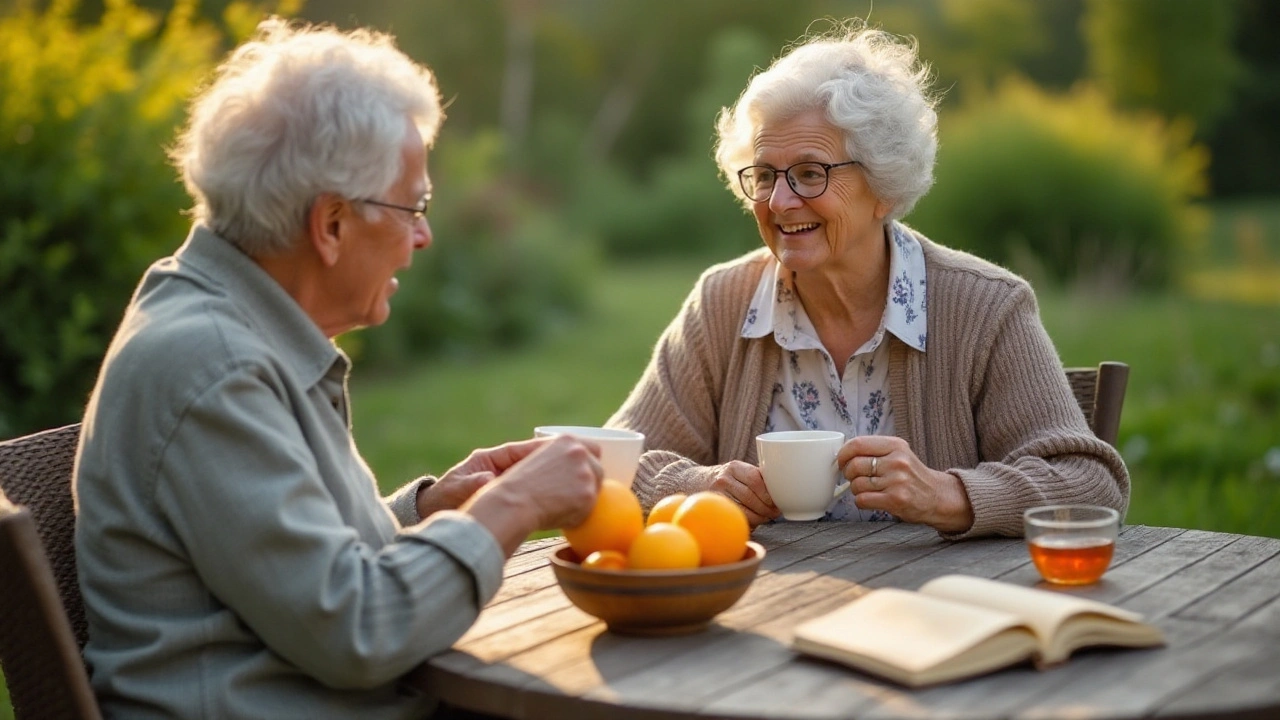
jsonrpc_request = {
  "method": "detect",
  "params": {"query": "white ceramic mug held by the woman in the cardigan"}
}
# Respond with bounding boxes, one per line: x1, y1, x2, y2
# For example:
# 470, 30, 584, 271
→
755, 430, 849, 520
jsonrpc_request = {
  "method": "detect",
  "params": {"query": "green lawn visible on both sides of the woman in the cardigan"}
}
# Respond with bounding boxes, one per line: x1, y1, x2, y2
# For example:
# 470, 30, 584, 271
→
352, 249, 1280, 537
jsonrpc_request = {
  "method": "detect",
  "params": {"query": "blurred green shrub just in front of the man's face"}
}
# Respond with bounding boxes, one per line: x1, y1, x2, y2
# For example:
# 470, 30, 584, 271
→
355, 126, 599, 366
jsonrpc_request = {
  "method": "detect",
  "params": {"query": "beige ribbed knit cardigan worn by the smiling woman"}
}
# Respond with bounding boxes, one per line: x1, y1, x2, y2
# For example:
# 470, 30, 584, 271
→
607, 231, 1129, 539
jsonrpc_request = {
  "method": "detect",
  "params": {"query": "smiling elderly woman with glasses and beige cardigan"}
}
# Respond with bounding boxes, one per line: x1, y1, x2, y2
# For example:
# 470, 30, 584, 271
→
608, 24, 1129, 538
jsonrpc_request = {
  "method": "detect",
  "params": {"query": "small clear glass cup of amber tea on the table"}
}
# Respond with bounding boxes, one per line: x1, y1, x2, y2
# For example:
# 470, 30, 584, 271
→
1023, 505, 1120, 585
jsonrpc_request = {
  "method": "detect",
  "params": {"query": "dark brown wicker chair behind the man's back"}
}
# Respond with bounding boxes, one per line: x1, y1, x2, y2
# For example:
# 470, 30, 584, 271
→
0, 424, 101, 720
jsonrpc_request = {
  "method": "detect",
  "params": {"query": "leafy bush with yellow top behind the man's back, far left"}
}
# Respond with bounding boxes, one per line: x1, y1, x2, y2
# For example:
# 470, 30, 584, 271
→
0, 0, 289, 437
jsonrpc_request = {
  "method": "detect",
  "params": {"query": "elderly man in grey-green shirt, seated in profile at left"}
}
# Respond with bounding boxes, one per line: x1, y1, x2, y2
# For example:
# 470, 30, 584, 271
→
76, 19, 600, 719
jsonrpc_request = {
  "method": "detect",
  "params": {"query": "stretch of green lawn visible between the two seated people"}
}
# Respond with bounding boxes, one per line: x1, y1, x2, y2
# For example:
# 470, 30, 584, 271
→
351, 254, 705, 491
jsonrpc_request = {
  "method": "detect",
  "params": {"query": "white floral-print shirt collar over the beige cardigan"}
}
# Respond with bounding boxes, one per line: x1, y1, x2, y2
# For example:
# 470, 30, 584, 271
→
741, 222, 928, 352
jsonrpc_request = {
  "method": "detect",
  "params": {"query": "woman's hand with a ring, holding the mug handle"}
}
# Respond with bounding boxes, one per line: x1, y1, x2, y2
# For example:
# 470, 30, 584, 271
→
836, 436, 973, 533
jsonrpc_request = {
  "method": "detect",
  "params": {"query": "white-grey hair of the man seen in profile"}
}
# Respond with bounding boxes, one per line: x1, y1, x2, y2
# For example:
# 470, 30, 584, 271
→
169, 18, 444, 256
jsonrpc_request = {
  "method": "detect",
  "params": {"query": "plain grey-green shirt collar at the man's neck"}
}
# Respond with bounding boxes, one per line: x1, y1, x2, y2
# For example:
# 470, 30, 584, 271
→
174, 224, 351, 386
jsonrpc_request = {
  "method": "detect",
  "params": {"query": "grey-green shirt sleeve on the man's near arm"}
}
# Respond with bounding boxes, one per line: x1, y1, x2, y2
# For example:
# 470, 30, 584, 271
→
155, 369, 503, 688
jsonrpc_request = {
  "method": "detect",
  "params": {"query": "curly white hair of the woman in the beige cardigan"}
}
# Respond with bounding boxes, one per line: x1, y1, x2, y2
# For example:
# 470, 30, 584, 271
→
716, 23, 938, 219
